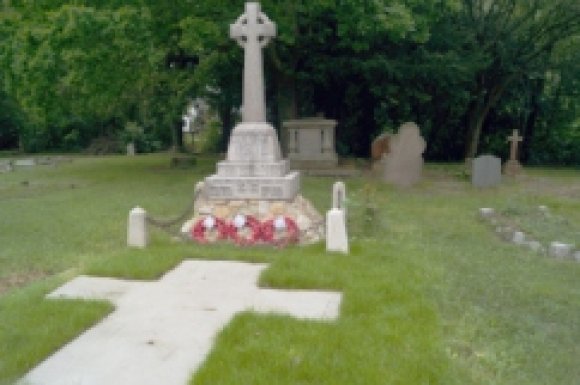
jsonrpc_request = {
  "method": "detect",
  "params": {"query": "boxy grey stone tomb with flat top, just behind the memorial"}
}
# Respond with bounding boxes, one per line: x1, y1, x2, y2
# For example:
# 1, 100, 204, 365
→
282, 117, 338, 169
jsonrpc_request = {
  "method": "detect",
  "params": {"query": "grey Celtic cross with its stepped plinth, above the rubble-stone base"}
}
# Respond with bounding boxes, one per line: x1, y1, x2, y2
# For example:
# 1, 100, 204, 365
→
205, 3, 300, 201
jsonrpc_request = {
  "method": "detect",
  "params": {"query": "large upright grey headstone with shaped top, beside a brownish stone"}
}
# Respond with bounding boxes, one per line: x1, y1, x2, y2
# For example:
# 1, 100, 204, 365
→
384, 122, 426, 187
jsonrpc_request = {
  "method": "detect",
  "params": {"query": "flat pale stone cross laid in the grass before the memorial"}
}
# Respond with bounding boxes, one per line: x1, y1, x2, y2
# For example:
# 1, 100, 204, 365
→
22, 261, 341, 385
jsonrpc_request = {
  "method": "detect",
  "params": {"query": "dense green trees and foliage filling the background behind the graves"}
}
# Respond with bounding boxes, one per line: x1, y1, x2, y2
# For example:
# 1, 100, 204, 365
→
0, 0, 580, 164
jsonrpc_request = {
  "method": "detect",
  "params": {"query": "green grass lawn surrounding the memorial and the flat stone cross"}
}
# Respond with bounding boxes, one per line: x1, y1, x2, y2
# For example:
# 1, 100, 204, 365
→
0, 155, 580, 385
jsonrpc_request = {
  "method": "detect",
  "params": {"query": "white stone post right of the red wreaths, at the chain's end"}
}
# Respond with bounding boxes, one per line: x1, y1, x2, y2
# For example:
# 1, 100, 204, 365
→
326, 182, 348, 254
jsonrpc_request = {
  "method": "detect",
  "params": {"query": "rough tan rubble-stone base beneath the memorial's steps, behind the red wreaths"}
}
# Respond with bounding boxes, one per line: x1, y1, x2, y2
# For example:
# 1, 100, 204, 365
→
181, 185, 325, 244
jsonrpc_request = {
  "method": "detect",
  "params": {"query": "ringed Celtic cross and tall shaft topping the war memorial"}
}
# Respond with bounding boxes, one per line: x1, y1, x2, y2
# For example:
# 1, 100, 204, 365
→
230, 3, 276, 123
